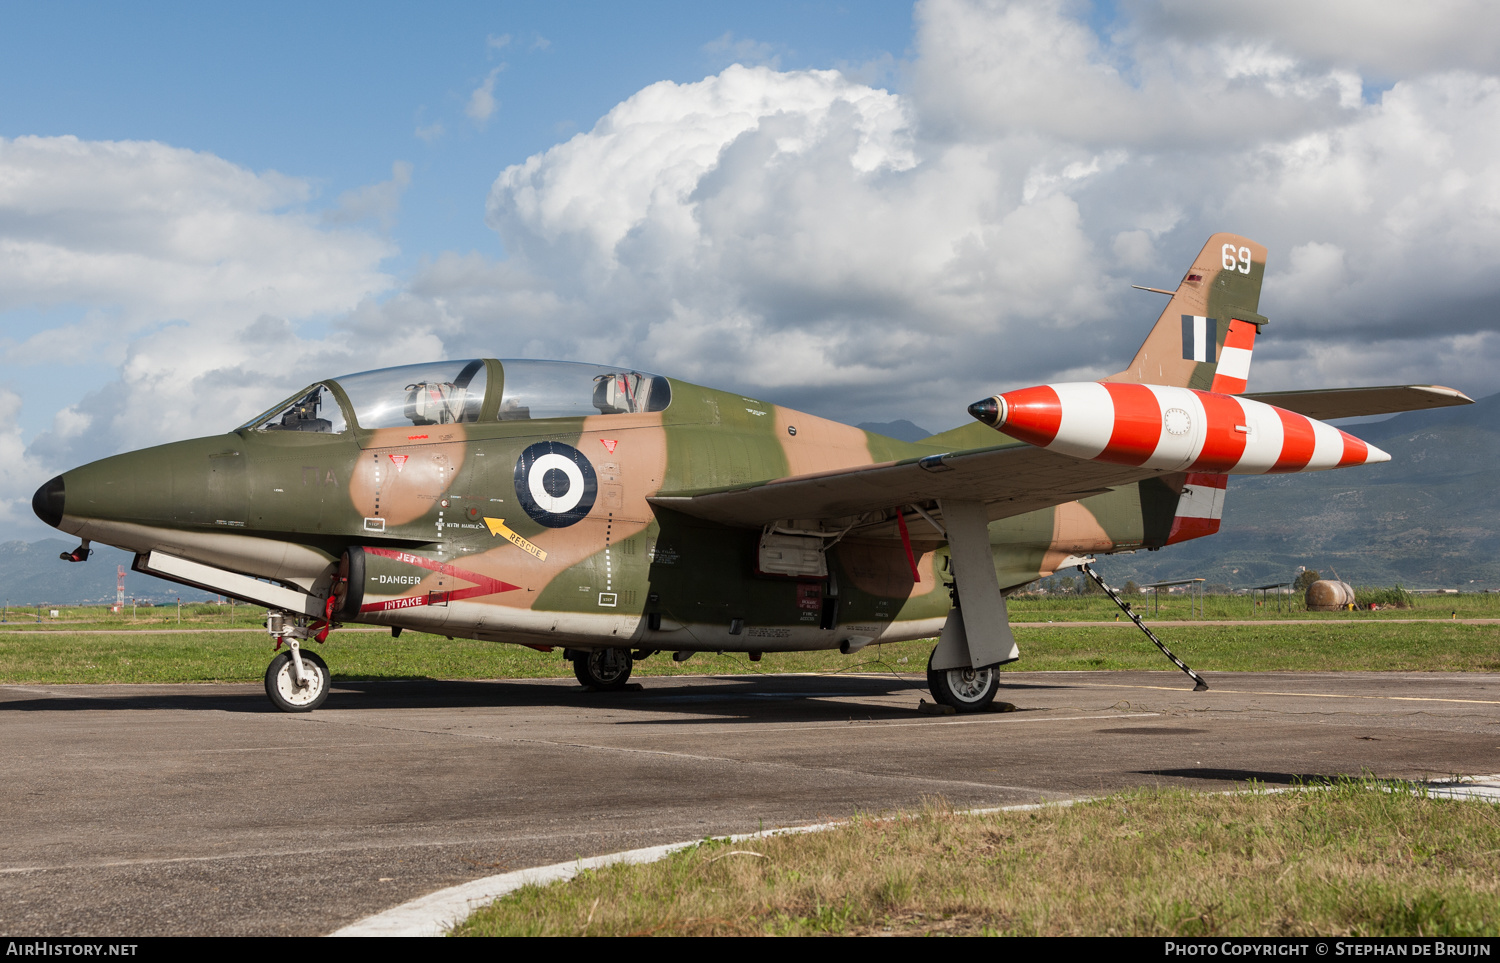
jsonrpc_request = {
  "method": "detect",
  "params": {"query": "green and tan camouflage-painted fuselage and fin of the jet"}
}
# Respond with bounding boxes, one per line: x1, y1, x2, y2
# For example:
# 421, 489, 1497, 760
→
26, 234, 1440, 666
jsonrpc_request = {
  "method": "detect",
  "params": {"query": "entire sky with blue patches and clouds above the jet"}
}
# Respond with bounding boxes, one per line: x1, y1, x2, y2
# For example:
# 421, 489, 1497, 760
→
0, 0, 1500, 537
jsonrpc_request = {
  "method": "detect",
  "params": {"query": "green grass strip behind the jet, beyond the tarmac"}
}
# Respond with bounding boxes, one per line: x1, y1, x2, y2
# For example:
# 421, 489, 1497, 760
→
0, 623, 1500, 684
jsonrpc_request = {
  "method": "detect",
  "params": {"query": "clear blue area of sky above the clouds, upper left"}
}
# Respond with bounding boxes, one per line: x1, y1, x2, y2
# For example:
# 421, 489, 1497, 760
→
0, 0, 912, 272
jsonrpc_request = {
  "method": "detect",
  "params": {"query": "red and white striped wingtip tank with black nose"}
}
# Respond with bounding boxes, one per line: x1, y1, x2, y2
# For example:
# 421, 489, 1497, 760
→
969, 381, 1391, 474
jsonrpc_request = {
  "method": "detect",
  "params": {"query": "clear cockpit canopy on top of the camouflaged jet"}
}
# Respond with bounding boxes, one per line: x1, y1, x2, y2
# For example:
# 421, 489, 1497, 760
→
240, 359, 672, 434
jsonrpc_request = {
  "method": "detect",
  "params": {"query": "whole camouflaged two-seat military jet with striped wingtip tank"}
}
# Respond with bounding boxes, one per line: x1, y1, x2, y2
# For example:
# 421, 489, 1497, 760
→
33, 234, 1470, 711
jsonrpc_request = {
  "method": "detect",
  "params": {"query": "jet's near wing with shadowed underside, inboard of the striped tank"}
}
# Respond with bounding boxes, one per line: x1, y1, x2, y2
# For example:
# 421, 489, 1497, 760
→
650, 444, 1166, 528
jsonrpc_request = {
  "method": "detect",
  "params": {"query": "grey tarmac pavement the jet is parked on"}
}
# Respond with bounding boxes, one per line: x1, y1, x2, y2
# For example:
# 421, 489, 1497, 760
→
0, 672, 1500, 936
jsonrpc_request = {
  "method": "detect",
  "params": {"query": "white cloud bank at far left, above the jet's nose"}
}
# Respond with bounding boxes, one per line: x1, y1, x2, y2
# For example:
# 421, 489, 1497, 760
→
0, 137, 396, 521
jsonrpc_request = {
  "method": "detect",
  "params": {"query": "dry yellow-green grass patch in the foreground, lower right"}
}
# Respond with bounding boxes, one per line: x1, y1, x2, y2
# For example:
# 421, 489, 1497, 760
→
456, 782, 1500, 936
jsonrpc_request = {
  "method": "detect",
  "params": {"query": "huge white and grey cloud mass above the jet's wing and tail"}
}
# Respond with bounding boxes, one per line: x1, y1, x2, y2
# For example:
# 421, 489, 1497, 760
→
447, 0, 1500, 426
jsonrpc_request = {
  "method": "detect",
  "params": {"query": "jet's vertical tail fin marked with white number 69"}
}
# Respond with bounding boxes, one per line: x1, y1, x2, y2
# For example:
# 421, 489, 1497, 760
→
1103, 234, 1266, 395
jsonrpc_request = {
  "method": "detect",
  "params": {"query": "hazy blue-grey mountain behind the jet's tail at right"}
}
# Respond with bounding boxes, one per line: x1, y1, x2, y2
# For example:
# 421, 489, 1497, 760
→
1103, 395, 1500, 591
